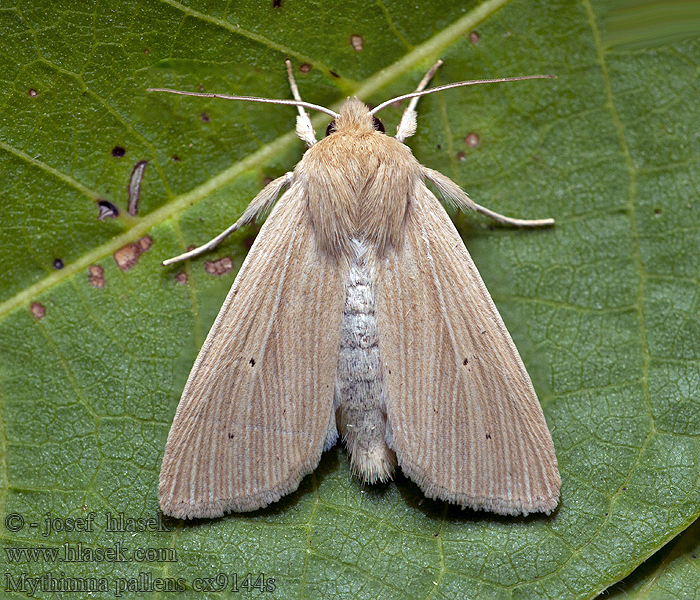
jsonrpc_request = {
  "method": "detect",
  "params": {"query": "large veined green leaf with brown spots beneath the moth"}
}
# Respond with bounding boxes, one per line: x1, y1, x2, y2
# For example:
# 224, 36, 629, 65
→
0, 0, 700, 598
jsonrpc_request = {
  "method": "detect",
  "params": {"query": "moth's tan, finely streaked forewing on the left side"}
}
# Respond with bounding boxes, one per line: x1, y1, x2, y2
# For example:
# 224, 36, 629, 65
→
159, 185, 345, 518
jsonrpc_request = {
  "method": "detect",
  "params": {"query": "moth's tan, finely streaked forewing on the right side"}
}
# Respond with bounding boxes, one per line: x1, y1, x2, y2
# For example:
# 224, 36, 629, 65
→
376, 182, 560, 514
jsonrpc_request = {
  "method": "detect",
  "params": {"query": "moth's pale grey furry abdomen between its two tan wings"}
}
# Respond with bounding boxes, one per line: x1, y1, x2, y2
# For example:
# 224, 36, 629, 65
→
335, 240, 396, 483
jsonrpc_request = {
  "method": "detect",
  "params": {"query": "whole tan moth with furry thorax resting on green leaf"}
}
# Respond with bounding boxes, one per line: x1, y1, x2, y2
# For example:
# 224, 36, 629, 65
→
149, 61, 560, 519
